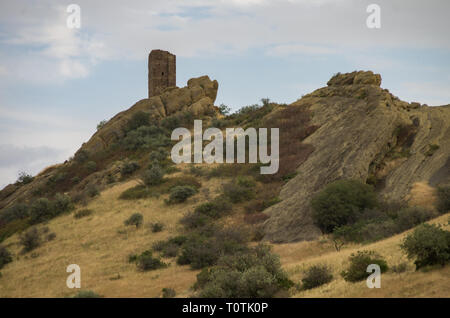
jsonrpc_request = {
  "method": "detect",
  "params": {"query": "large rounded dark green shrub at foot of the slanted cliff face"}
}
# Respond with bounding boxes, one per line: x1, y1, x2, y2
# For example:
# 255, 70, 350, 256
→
311, 180, 377, 233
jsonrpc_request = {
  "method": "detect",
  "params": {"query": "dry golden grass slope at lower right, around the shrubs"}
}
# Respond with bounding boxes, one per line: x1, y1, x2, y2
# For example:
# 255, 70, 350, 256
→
274, 214, 450, 297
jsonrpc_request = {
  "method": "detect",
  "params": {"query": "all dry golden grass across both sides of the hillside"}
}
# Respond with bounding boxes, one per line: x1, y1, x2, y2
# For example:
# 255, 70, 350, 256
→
0, 171, 450, 297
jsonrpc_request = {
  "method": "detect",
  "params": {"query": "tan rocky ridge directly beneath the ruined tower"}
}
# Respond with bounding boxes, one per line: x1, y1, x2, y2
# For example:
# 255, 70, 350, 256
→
81, 76, 219, 153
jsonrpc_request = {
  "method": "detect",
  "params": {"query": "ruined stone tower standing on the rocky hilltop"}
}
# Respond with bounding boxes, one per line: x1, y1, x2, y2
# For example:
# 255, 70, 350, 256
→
148, 50, 177, 98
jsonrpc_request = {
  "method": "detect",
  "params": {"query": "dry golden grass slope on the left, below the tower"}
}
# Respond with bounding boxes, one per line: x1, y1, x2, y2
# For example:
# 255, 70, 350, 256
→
0, 171, 225, 297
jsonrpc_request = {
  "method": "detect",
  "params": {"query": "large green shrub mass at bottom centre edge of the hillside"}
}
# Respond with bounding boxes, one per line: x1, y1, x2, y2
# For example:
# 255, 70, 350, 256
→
194, 245, 293, 298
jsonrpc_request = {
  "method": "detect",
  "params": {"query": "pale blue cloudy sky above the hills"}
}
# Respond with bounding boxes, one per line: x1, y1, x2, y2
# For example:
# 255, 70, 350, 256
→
0, 0, 450, 188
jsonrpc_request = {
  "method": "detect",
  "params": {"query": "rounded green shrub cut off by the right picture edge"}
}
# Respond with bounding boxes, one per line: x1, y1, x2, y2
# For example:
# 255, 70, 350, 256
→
401, 224, 450, 269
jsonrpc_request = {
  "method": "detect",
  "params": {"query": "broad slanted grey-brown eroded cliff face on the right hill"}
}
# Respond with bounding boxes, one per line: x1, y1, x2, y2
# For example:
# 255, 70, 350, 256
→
264, 72, 450, 242
